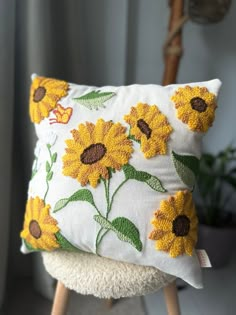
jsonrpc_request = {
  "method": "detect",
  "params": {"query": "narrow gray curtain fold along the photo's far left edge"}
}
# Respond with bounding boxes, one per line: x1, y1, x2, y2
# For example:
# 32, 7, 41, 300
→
0, 0, 15, 308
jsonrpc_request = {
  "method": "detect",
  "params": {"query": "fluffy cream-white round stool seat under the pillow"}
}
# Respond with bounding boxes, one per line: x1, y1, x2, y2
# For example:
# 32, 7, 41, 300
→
42, 251, 175, 299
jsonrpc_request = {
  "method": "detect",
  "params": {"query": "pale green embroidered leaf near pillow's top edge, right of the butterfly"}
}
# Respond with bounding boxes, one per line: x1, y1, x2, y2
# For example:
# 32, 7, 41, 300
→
73, 90, 115, 110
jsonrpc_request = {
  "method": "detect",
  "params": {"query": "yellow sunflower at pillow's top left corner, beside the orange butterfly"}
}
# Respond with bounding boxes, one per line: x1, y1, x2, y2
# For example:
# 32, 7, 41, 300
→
29, 77, 69, 124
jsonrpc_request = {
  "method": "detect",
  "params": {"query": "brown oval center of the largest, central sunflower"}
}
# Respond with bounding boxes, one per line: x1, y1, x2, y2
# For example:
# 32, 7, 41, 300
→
80, 143, 107, 164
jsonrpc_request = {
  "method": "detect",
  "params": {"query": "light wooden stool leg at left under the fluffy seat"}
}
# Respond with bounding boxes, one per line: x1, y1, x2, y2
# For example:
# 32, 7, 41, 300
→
51, 281, 70, 315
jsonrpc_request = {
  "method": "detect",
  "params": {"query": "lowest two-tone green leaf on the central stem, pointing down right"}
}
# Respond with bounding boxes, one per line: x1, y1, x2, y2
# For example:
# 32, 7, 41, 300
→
94, 215, 143, 252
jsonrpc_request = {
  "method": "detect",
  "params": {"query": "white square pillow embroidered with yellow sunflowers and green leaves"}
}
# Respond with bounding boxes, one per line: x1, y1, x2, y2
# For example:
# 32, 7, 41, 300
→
21, 76, 221, 288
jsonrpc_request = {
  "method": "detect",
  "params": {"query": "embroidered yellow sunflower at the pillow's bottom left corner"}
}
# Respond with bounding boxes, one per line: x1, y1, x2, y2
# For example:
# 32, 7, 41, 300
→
20, 197, 60, 251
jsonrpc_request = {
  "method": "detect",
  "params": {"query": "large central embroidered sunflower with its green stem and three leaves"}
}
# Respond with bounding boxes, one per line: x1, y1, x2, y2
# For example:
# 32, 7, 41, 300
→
53, 119, 166, 254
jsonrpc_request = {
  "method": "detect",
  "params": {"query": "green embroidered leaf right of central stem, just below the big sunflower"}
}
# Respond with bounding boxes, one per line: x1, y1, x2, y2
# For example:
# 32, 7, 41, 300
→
123, 164, 166, 192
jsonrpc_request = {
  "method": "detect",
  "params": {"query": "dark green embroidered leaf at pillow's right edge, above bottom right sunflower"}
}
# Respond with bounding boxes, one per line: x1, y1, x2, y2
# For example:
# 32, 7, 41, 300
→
171, 151, 200, 188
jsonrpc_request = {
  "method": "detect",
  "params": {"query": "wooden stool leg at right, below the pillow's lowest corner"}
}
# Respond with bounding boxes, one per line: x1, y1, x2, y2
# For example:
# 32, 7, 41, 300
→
164, 281, 180, 315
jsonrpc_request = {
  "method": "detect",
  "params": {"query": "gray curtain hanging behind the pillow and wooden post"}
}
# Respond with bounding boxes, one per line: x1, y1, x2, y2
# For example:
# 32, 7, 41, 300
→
0, 0, 236, 307
